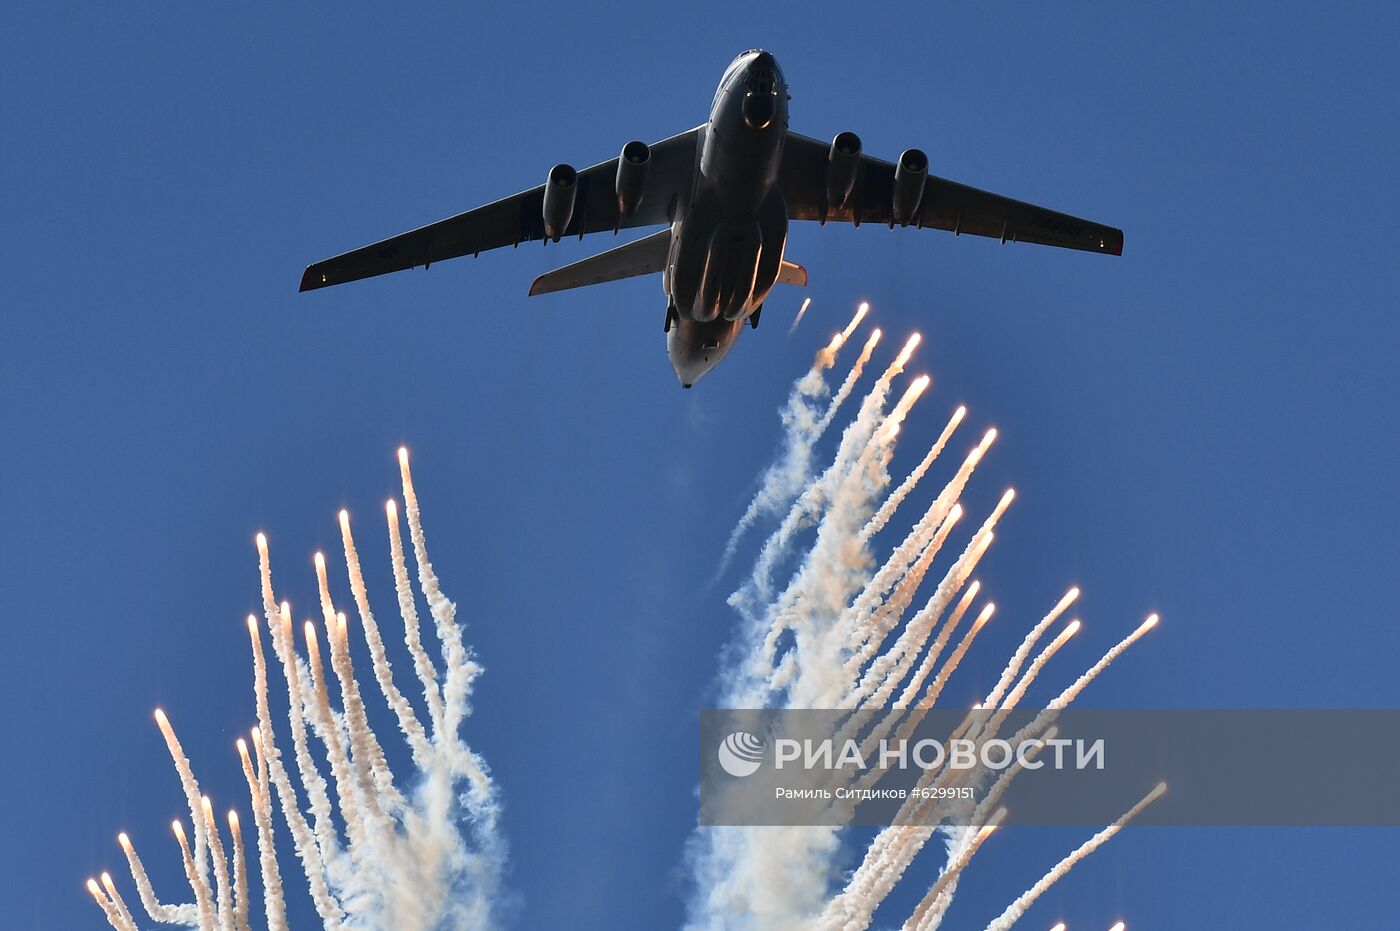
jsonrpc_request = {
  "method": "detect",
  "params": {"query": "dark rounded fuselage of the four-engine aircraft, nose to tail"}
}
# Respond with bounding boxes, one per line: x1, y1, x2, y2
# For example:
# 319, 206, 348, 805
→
662, 50, 788, 388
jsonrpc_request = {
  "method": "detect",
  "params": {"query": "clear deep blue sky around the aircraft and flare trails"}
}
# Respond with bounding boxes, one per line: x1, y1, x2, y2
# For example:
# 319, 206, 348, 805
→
0, 3, 1400, 931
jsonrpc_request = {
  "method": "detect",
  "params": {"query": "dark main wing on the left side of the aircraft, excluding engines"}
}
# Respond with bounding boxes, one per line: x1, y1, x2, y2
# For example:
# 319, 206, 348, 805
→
301, 127, 700, 291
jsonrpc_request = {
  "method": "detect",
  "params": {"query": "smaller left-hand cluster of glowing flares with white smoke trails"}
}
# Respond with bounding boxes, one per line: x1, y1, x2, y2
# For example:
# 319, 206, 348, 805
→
87, 449, 505, 931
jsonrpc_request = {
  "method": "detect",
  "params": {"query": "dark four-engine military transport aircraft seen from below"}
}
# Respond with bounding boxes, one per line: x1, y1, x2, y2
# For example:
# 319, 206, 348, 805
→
301, 49, 1123, 388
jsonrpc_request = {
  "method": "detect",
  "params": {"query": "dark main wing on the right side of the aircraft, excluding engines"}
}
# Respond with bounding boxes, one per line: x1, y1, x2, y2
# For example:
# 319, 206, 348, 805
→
778, 133, 1123, 255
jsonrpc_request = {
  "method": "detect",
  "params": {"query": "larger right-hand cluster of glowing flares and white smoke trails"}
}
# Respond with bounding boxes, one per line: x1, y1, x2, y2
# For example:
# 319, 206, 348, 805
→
687, 308, 1163, 931
